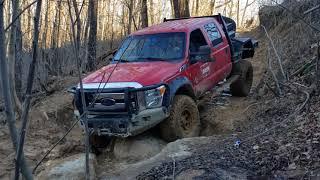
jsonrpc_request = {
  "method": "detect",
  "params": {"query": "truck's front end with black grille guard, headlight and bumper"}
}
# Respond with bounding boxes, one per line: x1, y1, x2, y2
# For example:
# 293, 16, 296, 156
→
74, 84, 169, 137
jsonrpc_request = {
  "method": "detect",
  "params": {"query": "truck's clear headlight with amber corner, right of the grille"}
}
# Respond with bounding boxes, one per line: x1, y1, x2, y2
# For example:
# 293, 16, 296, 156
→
145, 86, 166, 108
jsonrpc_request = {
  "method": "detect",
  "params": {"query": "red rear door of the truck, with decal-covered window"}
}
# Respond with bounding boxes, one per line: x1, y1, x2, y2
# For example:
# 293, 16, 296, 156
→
204, 22, 232, 85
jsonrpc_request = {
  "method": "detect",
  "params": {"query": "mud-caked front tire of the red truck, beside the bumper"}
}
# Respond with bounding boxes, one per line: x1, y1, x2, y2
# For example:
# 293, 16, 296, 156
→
159, 95, 200, 142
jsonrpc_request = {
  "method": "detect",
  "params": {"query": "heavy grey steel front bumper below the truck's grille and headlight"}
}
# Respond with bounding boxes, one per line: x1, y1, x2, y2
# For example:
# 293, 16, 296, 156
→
75, 107, 169, 137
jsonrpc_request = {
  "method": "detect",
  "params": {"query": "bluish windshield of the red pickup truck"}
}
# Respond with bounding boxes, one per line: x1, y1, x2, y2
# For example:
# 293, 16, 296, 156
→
114, 32, 185, 62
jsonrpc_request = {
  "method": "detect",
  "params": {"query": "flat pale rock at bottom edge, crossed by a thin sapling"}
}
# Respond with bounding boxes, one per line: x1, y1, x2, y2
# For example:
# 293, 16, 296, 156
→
36, 153, 97, 180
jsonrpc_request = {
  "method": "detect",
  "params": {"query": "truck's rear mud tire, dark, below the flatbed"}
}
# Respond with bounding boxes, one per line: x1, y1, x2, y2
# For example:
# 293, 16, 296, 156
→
230, 60, 253, 97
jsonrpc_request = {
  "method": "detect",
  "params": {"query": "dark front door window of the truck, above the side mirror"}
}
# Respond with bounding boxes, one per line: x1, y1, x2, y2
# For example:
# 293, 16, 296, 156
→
189, 29, 208, 52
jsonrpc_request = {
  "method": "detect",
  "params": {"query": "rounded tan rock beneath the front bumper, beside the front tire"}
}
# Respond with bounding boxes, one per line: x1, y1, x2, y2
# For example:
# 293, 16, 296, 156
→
114, 134, 166, 161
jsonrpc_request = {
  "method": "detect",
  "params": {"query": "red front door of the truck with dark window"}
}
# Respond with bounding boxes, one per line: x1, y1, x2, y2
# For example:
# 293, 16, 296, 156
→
187, 29, 214, 96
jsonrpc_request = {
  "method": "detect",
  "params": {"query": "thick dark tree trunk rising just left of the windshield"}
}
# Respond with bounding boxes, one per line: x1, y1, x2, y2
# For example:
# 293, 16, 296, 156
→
87, 0, 98, 71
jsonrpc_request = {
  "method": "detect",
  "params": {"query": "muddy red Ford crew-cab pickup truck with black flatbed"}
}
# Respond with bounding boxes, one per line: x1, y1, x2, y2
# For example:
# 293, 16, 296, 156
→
73, 15, 257, 141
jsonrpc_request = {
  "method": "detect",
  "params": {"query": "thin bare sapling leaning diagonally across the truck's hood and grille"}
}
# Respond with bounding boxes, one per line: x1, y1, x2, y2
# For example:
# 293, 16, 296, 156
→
32, 39, 131, 174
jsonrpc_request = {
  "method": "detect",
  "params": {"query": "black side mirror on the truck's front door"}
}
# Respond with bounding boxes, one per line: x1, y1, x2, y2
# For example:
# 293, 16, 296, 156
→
190, 45, 214, 64
